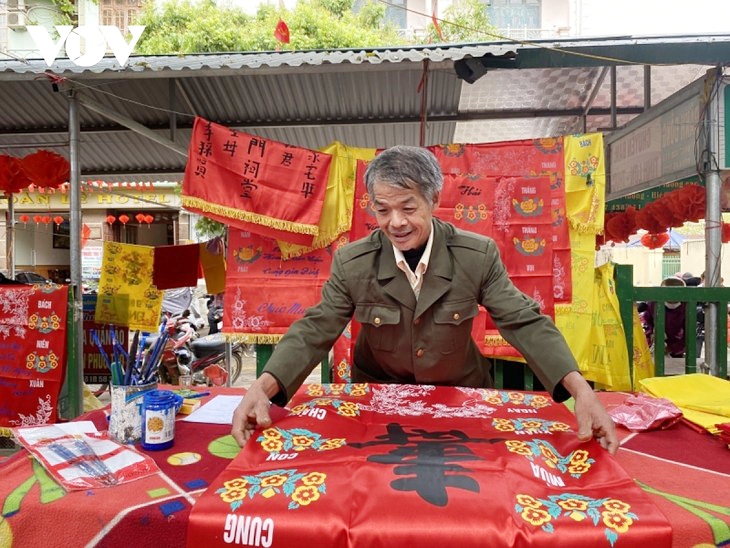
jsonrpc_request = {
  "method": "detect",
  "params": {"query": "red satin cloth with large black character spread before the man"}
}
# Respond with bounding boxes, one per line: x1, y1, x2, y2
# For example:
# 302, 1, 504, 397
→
187, 384, 672, 547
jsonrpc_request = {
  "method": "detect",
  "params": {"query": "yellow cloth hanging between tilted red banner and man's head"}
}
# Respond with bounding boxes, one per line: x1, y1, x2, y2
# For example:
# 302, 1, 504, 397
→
277, 141, 376, 259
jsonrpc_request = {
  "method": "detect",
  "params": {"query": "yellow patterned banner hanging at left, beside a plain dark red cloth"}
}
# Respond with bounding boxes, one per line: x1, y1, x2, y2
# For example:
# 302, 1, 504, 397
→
95, 242, 162, 331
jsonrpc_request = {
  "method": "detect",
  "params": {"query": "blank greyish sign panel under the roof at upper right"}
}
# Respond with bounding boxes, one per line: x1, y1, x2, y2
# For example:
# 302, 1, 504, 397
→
606, 74, 705, 201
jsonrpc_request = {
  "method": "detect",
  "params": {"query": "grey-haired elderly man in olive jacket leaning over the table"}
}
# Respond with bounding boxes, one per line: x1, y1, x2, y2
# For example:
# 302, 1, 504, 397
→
232, 146, 618, 453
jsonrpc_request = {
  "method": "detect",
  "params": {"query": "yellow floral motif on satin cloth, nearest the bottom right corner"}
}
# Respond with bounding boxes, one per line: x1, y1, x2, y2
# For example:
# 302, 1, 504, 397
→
515, 493, 639, 546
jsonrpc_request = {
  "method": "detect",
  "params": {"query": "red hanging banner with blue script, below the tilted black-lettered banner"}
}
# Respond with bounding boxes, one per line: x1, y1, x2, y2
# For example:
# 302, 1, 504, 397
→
223, 229, 332, 344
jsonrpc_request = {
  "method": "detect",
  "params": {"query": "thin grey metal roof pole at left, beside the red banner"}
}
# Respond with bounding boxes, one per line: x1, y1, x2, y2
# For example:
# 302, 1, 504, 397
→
66, 91, 84, 418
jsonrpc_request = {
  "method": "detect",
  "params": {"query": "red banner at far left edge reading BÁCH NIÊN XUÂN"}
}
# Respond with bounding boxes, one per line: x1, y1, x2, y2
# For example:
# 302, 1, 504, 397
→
0, 284, 68, 427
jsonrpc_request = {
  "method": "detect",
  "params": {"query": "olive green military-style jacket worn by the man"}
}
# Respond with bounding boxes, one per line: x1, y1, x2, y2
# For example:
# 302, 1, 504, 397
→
265, 219, 578, 403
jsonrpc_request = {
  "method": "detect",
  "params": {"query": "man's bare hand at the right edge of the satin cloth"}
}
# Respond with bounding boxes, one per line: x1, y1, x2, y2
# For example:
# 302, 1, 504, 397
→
562, 371, 618, 455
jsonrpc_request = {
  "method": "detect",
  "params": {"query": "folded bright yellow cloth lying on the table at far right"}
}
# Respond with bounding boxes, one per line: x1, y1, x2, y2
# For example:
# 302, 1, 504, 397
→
639, 373, 730, 434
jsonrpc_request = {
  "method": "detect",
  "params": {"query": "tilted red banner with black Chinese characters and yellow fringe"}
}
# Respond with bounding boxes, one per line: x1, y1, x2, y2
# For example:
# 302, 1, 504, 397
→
182, 118, 332, 245
